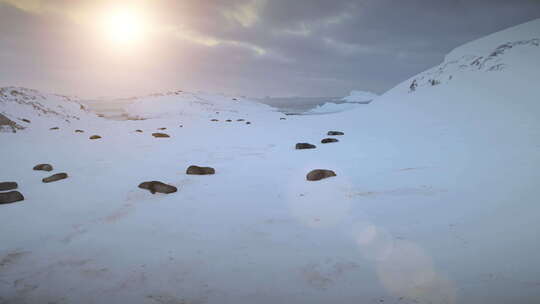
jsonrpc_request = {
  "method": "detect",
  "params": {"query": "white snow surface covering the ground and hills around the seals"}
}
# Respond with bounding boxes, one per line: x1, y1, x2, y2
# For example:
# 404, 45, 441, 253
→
0, 20, 540, 304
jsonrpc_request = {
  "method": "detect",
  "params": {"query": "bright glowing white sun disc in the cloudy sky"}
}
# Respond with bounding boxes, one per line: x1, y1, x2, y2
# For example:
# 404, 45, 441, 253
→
103, 9, 147, 45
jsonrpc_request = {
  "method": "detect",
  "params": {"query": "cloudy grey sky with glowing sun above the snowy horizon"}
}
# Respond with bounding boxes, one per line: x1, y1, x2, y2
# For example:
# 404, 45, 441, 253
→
0, 0, 540, 98
